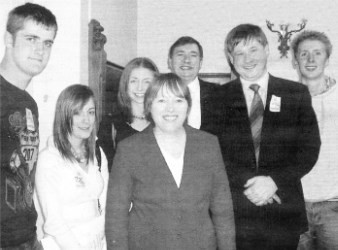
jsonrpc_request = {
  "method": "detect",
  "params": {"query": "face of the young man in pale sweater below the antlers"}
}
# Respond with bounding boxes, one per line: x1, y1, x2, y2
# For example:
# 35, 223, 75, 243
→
296, 40, 329, 79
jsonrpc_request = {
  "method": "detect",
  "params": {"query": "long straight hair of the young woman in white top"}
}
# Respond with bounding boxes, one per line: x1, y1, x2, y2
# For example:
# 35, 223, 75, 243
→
53, 84, 97, 162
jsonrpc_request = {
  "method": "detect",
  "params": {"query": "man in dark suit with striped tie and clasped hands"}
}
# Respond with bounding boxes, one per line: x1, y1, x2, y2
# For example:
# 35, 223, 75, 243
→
217, 24, 320, 250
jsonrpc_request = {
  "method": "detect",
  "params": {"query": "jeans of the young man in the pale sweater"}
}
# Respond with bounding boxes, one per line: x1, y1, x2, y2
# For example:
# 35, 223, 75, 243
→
297, 201, 338, 250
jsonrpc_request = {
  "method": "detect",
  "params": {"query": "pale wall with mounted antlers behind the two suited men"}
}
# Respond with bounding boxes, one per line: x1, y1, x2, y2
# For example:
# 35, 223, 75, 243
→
137, 0, 338, 80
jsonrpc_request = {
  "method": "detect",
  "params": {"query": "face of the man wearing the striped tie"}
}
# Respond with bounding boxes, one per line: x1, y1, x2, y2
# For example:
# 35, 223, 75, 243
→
230, 39, 269, 81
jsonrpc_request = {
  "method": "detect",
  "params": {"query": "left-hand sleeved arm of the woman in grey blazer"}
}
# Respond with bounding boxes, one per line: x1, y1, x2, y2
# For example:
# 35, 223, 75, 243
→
106, 143, 132, 250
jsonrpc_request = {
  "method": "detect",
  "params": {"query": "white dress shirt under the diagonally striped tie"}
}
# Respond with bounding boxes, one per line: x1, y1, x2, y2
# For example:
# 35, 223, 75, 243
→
241, 72, 269, 116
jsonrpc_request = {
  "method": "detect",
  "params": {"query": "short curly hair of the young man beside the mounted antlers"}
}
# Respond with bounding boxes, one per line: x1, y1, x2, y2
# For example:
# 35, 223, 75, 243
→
291, 30, 332, 58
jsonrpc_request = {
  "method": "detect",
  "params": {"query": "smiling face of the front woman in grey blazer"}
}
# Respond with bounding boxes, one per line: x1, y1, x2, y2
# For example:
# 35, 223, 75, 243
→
150, 87, 188, 133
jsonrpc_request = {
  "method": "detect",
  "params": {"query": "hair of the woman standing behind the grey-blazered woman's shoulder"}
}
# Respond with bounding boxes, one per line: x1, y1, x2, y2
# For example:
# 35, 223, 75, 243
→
117, 57, 158, 122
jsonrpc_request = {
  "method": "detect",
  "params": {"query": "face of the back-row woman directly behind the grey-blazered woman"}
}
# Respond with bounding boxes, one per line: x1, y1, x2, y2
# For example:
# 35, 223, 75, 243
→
128, 68, 154, 104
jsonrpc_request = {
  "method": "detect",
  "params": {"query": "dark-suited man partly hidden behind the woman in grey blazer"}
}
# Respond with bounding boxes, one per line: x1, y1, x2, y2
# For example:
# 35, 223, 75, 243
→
168, 36, 219, 134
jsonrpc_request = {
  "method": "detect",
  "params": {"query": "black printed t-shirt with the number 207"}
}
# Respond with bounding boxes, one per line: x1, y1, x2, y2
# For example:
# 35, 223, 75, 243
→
0, 76, 39, 247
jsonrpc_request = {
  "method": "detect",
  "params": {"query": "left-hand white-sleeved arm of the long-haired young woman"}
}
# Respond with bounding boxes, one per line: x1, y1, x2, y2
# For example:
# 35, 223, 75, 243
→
35, 152, 81, 250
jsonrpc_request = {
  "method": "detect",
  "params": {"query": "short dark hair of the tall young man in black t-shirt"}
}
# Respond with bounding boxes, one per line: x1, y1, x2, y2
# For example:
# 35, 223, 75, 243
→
7, 3, 58, 37
